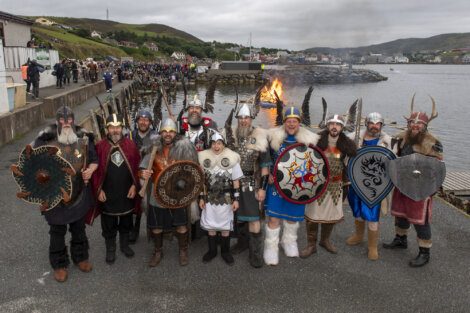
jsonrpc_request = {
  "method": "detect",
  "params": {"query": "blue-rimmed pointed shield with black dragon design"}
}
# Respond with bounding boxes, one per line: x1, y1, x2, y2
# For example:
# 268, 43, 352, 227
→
348, 146, 396, 208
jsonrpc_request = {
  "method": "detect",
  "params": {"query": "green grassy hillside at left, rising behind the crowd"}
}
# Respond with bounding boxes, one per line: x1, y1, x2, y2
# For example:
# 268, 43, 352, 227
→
29, 17, 221, 60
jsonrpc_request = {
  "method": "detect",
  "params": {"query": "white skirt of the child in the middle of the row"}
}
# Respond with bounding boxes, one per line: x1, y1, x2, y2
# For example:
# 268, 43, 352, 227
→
201, 203, 233, 231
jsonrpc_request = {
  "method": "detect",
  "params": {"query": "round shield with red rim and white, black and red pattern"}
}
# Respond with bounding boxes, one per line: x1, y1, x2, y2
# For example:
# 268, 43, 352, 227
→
274, 143, 330, 204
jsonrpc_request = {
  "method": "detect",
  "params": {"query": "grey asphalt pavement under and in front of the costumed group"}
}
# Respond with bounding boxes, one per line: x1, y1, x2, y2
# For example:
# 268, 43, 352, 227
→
0, 81, 470, 313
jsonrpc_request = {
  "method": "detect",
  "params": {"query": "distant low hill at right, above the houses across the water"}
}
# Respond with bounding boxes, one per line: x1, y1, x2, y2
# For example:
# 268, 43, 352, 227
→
304, 33, 470, 55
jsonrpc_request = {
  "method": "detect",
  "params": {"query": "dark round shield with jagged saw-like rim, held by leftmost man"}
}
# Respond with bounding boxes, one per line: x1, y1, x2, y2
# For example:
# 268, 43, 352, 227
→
11, 145, 75, 211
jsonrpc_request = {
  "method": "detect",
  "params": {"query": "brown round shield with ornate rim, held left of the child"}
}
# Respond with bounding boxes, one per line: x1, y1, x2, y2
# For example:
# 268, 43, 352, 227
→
154, 161, 204, 209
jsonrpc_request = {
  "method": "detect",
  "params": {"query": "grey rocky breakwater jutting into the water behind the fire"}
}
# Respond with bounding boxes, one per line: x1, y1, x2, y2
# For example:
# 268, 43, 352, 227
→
196, 66, 388, 85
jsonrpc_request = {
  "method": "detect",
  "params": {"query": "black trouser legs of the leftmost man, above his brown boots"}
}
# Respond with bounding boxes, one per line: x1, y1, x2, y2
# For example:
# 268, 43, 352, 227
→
49, 217, 89, 269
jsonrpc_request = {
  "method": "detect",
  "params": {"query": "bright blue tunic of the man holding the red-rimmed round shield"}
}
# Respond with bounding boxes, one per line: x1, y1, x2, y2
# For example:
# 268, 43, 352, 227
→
265, 135, 305, 222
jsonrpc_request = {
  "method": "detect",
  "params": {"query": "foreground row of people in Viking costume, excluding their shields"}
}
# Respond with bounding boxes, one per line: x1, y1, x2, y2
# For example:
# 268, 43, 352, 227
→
12, 86, 443, 282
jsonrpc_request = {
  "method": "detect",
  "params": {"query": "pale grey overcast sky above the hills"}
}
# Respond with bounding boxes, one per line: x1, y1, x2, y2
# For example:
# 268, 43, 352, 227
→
0, 0, 470, 50
